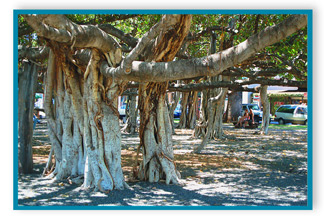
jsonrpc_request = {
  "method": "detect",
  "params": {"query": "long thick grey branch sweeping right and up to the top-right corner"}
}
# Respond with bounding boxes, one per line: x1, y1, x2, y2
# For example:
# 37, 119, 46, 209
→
100, 15, 307, 82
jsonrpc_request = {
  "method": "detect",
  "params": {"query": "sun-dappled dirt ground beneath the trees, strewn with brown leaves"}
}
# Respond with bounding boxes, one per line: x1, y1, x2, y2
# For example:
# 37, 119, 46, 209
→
18, 123, 307, 206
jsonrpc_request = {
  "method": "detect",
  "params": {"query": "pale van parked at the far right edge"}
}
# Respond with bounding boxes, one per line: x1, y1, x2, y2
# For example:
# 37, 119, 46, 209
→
275, 105, 307, 125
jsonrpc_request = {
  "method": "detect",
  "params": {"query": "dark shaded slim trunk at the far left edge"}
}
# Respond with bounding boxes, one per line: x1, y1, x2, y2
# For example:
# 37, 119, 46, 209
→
18, 62, 38, 174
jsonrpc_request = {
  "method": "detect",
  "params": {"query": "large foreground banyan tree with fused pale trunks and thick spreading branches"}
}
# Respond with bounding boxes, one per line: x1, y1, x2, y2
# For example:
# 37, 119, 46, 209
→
19, 14, 307, 192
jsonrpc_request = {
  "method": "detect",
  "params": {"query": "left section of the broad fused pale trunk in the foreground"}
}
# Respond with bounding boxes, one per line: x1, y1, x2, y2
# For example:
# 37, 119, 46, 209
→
44, 48, 84, 180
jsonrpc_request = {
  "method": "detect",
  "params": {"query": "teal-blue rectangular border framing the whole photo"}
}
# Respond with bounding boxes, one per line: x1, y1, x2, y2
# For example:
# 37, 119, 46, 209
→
13, 9, 313, 210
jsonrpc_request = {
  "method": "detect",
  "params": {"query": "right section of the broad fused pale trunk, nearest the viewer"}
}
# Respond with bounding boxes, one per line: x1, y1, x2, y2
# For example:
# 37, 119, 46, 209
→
83, 50, 127, 192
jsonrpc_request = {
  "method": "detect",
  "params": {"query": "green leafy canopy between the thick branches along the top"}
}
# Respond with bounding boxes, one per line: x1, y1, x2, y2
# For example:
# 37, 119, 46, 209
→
18, 14, 307, 80
